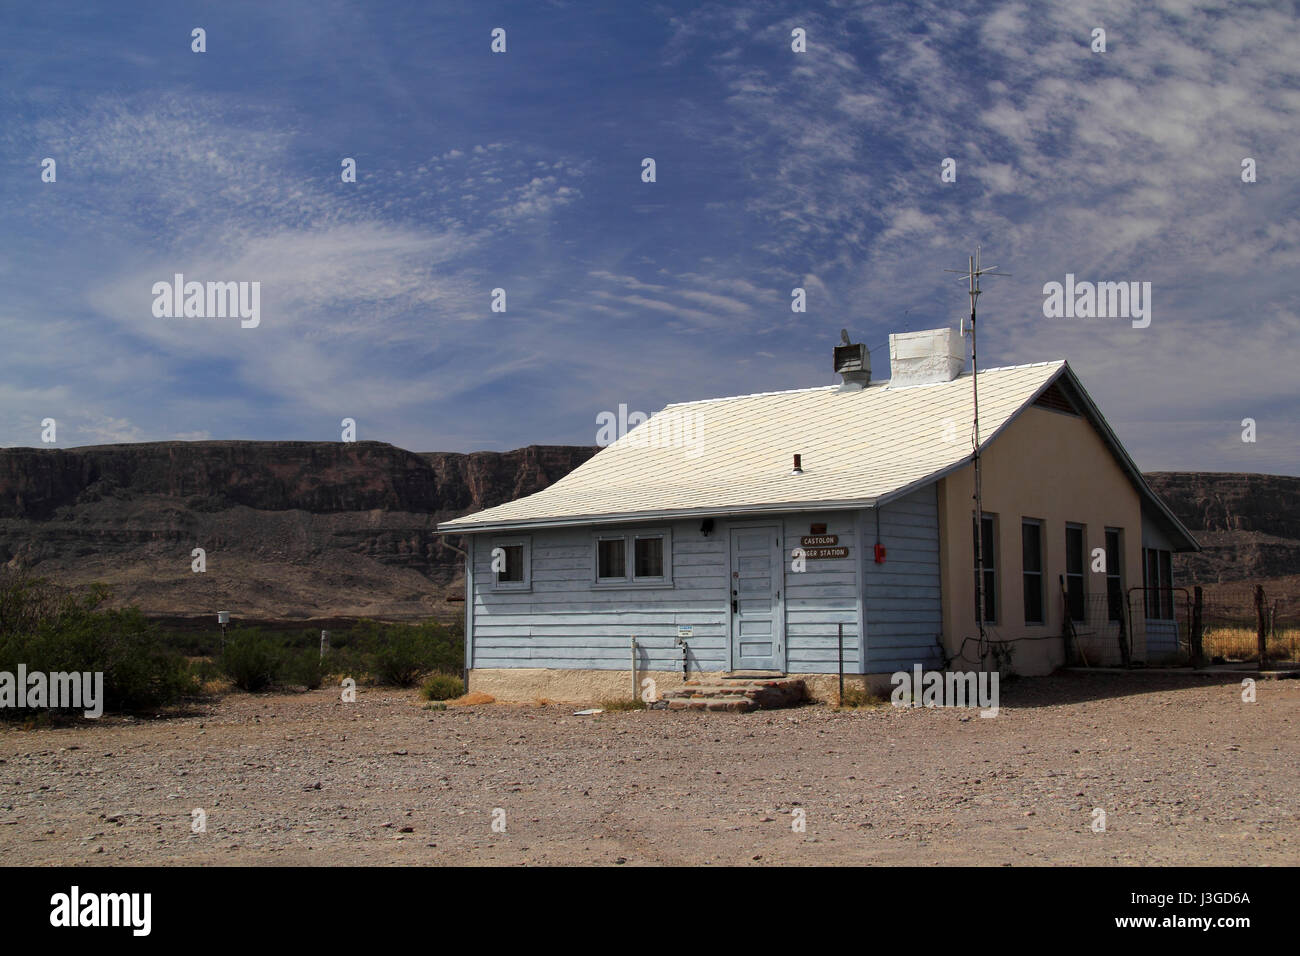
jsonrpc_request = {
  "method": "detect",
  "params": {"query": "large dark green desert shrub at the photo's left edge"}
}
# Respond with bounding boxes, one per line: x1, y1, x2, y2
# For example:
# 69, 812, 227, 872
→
0, 571, 198, 713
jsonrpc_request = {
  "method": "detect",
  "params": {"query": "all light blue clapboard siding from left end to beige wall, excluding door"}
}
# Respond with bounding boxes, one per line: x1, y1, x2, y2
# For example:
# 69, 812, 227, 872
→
467, 485, 941, 674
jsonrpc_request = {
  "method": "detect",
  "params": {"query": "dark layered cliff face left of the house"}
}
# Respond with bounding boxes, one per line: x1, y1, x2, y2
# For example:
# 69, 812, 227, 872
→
0, 441, 597, 618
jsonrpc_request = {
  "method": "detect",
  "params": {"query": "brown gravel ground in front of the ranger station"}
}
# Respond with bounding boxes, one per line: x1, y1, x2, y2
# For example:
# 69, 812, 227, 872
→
0, 674, 1300, 866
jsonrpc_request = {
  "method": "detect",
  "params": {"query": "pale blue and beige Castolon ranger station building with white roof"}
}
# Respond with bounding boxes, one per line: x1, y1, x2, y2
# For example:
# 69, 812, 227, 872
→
439, 329, 1197, 700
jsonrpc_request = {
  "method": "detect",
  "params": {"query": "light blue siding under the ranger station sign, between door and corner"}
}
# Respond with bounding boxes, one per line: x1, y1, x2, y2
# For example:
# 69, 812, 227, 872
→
781, 511, 862, 674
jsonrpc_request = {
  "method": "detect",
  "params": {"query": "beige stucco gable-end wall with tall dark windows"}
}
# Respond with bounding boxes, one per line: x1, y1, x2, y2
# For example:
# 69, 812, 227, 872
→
939, 407, 1143, 675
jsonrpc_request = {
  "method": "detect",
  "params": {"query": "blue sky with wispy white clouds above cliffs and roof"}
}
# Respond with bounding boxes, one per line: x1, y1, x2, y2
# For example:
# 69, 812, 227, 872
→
0, 0, 1300, 475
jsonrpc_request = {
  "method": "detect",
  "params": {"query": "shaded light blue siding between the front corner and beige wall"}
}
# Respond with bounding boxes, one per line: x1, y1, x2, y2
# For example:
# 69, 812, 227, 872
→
862, 485, 944, 674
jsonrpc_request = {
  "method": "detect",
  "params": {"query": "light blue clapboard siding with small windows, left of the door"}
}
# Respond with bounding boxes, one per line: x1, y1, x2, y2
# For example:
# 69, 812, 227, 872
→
471, 519, 728, 671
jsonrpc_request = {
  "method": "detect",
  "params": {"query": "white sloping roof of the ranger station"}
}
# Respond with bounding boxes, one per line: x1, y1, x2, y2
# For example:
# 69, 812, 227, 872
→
438, 362, 1066, 531
